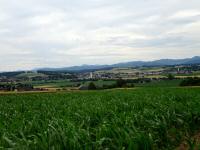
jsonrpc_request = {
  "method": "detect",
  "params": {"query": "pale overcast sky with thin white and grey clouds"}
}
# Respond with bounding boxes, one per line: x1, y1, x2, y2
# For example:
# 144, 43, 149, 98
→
0, 0, 200, 71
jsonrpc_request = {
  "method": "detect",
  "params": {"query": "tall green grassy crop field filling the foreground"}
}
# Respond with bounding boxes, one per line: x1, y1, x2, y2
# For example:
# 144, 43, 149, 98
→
0, 87, 200, 150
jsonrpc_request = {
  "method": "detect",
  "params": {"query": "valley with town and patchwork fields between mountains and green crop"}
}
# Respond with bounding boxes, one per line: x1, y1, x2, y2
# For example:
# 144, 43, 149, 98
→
0, 64, 200, 91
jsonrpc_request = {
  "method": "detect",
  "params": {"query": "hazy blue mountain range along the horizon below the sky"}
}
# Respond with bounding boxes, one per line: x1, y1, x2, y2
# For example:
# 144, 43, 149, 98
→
37, 56, 200, 72
